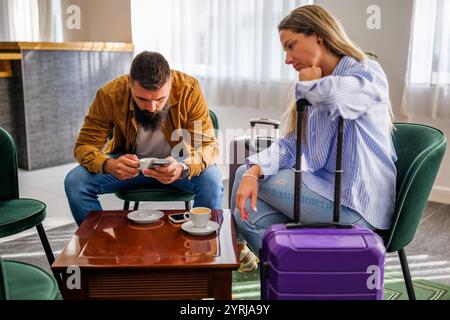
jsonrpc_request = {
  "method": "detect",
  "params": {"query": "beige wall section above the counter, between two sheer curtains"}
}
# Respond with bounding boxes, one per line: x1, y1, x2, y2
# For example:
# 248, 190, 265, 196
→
61, 0, 131, 43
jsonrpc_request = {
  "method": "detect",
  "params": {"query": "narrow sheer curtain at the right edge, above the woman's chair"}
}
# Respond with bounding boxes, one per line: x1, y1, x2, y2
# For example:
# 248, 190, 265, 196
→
402, 0, 450, 119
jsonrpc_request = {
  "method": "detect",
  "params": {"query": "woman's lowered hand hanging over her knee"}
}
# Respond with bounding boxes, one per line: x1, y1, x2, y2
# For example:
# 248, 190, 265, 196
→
236, 165, 261, 220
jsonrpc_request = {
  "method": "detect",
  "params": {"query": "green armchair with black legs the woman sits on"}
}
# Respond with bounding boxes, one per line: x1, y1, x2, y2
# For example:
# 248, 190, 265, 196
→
382, 123, 447, 300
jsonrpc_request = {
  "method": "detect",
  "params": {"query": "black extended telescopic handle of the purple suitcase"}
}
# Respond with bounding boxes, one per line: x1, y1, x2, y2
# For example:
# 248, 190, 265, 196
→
287, 99, 352, 229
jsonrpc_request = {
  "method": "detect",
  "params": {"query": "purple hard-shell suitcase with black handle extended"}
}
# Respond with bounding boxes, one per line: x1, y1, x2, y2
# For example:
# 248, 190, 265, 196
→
260, 99, 386, 300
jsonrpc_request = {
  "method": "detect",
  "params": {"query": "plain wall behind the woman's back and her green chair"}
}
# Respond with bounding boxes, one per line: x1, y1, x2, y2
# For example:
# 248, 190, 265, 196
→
315, 0, 450, 203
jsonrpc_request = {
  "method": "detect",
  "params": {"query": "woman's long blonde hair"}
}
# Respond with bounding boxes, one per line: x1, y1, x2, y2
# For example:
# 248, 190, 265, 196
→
278, 5, 392, 138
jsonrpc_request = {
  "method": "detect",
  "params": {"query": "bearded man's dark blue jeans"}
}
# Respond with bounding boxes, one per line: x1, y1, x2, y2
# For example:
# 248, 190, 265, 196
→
64, 166, 223, 225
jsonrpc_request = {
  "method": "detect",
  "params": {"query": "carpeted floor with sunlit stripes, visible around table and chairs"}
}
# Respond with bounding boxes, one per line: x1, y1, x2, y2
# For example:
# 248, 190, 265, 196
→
0, 218, 450, 300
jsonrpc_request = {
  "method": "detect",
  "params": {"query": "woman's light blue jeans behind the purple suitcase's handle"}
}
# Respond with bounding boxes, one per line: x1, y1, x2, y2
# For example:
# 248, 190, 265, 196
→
230, 165, 375, 253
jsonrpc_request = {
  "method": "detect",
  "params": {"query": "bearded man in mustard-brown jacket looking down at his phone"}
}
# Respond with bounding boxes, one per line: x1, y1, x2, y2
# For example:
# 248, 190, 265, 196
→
65, 51, 223, 225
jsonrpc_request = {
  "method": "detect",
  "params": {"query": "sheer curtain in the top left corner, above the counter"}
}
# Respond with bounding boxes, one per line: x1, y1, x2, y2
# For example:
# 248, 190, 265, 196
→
0, 0, 62, 42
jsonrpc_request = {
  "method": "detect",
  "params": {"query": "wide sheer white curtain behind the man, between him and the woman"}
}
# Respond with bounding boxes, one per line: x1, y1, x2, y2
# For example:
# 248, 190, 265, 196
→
131, 0, 312, 109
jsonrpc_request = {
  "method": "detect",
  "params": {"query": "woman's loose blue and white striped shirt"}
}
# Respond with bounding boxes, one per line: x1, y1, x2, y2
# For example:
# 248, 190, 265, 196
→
246, 56, 397, 229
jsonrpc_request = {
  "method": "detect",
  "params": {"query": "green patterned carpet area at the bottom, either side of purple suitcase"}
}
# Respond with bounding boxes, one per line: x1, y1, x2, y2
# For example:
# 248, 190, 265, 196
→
233, 271, 450, 300
